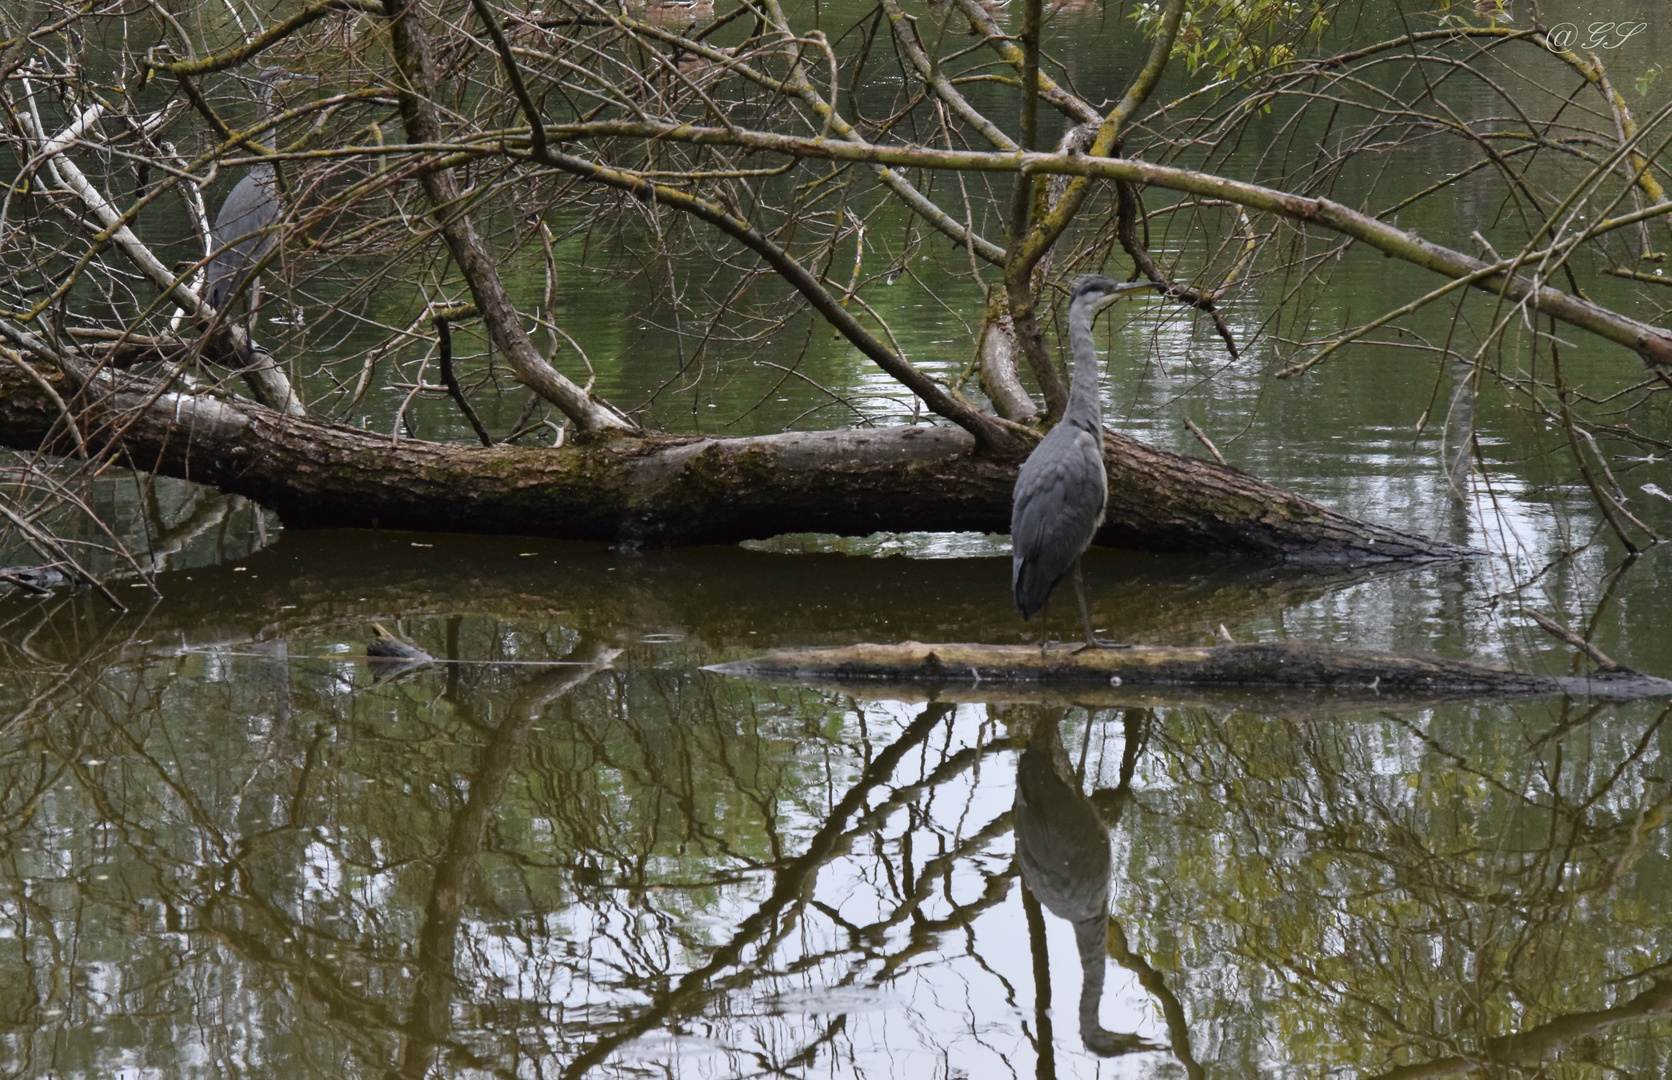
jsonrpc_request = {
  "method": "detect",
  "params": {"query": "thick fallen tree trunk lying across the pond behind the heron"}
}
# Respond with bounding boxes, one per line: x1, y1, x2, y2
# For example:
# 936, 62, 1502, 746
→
0, 368, 1465, 562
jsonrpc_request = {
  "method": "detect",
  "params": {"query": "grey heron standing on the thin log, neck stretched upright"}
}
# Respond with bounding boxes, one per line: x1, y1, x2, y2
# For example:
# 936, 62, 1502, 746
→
1010, 274, 1165, 649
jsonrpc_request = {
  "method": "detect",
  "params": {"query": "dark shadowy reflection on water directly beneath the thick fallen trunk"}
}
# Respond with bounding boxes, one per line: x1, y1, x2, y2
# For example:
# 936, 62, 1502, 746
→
0, 532, 1424, 659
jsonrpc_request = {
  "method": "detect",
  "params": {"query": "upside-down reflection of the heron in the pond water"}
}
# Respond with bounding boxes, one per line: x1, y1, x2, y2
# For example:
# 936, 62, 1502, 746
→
1013, 709, 1157, 1057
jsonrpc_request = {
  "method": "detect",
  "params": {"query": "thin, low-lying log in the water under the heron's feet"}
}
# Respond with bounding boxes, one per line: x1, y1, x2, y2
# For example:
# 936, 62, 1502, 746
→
709, 642, 1672, 700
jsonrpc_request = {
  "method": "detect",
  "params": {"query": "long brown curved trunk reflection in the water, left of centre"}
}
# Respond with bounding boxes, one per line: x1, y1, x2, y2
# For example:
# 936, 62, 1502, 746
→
395, 649, 614, 1080
